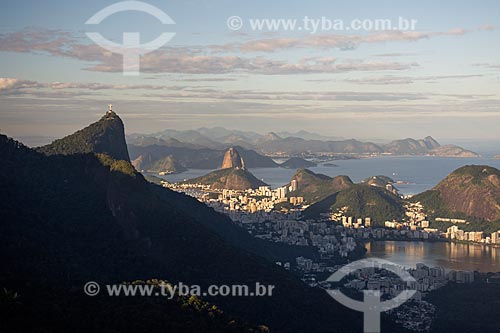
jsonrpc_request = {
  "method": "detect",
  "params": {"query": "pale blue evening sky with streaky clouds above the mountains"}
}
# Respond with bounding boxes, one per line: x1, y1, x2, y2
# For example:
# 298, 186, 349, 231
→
0, 0, 500, 141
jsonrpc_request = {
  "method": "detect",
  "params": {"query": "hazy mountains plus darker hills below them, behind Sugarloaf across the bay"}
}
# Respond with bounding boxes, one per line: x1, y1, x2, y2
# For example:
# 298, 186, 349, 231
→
127, 127, 479, 173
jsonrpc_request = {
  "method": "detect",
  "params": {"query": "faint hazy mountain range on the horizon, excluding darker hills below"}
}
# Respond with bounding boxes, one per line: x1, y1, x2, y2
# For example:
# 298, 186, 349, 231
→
127, 127, 479, 163
